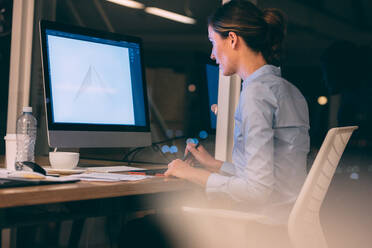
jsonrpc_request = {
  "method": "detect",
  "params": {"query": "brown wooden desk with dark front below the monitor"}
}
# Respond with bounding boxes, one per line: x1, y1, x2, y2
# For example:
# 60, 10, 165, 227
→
0, 158, 198, 227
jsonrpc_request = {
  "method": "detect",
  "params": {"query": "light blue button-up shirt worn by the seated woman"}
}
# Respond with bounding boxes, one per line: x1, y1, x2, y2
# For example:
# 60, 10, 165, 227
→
206, 65, 310, 223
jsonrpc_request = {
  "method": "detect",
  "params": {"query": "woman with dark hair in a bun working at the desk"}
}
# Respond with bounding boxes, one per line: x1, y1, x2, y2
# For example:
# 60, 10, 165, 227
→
165, 0, 309, 223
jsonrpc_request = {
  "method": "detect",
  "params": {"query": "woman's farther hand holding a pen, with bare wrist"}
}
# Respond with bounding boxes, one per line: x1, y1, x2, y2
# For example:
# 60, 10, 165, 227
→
185, 143, 223, 172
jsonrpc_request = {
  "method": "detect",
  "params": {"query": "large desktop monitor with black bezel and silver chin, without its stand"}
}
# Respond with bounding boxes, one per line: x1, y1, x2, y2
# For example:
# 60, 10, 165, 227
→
40, 21, 151, 148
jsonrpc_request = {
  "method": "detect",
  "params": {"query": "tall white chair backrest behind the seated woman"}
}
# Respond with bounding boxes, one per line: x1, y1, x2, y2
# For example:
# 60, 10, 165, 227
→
288, 126, 358, 248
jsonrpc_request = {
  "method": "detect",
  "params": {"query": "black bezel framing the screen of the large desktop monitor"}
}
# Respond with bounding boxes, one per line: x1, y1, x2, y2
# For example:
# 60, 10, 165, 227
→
39, 20, 150, 132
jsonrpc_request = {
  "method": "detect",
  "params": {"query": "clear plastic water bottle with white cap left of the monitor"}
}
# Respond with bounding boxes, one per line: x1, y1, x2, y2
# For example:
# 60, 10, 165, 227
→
15, 107, 37, 170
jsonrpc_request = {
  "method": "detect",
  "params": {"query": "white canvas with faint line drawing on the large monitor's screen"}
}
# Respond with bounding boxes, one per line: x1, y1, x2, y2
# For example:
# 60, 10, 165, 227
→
48, 35, 135, 125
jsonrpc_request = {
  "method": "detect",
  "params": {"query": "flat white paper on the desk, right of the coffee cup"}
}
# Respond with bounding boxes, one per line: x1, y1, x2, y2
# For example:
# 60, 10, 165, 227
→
66, 172, 152, 182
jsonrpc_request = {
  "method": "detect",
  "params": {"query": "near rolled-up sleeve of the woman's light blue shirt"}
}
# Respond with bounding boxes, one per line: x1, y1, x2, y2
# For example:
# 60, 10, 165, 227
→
206, 83, 277, 204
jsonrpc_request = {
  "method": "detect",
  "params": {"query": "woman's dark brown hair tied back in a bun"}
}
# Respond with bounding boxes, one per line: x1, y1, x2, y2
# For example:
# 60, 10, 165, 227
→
208, 0, 286, 65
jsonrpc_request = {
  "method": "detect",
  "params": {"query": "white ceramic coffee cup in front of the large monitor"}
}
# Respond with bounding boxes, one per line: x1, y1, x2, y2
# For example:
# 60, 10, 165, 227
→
49, 152, 80, 169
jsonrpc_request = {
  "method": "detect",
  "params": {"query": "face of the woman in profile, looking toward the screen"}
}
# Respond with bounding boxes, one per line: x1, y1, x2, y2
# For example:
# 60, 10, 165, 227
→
208, 26, 235, 76
